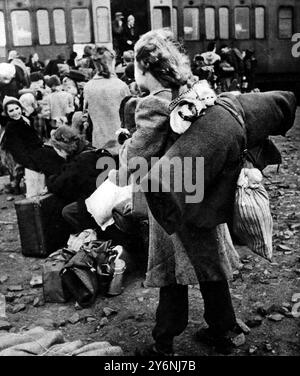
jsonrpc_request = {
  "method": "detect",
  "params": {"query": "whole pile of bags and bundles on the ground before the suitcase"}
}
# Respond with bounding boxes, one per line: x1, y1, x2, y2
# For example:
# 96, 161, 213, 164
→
42, 238, 125, 308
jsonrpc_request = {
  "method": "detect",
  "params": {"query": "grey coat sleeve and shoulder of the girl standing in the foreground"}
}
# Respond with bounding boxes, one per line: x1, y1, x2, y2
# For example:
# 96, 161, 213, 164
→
119, 96, 170, 171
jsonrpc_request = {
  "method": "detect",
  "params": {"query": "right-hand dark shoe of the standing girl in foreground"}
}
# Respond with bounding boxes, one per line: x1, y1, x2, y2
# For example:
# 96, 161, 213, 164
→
195, 328, 234, 355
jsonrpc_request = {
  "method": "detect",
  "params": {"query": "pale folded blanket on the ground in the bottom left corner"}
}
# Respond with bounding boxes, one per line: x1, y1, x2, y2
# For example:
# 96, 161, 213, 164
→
0, 327, 123, 356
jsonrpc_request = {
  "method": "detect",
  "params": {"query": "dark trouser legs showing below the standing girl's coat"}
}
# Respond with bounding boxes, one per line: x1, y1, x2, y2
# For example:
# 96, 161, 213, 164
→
152, 280, 236, 352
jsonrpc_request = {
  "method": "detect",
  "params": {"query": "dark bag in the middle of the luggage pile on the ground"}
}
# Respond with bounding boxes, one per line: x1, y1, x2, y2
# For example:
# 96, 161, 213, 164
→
60, 240, 118, 308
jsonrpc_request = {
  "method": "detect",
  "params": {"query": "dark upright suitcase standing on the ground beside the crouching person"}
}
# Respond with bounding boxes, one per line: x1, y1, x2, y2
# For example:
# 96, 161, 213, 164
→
15, 193, 69, 257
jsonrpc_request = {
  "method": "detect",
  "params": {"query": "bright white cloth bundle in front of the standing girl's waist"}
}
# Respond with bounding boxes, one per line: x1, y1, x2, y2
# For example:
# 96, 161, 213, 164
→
85, 179, 132, 231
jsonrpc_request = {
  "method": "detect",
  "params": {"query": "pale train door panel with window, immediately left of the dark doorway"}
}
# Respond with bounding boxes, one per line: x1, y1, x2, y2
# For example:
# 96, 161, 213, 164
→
92, 0, 112, 48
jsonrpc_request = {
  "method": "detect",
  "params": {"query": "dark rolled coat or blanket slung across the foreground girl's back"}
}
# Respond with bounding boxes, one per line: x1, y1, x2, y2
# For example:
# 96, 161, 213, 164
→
144, 92, 296, 280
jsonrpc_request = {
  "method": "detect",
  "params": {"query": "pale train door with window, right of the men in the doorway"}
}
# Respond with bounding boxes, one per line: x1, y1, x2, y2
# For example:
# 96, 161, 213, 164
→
149, 0, 173, 30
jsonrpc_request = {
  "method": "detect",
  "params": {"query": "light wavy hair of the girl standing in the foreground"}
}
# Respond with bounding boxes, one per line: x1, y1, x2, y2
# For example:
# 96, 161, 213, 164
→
135, 30, 192, 89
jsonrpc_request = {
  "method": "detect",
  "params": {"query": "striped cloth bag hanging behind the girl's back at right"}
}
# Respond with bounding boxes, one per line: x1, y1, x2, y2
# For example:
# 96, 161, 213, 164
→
233, 168, 273, 261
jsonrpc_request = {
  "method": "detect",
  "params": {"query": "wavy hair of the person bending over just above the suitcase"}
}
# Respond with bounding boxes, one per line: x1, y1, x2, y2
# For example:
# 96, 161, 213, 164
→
50, 125, 86, 156
